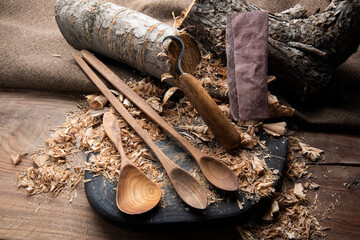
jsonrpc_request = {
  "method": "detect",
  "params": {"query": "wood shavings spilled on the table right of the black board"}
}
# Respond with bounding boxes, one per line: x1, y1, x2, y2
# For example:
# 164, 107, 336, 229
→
238, 137, 327, 240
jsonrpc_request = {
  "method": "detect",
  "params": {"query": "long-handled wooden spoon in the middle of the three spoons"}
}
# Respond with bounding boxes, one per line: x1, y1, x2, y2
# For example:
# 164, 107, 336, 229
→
73, 54, 207, 209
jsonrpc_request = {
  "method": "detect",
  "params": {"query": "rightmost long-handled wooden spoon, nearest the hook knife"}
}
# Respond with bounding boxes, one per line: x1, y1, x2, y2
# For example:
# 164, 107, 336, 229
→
81, 50, 239, 191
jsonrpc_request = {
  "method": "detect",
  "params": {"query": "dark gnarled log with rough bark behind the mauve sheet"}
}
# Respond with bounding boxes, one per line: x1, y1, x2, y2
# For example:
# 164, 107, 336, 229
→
178, 0, 360, 100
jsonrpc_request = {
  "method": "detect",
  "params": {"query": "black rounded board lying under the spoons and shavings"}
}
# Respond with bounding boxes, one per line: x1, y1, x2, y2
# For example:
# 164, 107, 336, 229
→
85, 129, 287, 229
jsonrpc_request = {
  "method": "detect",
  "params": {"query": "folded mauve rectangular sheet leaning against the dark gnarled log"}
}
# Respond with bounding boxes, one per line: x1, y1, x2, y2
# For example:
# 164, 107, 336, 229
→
226, 11, 269, 120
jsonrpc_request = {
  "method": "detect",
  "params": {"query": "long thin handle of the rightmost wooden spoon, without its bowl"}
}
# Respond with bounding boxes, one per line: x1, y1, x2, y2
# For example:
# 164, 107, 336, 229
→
81, 50, 206, 164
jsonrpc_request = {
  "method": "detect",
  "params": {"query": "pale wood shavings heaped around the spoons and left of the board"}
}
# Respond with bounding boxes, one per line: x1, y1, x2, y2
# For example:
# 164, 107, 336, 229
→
14, 73, 277, 203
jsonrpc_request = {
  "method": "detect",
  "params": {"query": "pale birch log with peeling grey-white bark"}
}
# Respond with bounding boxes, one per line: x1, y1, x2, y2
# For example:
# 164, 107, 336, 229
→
55, 0, 201, 84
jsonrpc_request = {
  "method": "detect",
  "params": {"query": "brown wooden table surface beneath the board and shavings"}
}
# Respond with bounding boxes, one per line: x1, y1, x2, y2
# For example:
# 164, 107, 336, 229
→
0, 90, 360, 239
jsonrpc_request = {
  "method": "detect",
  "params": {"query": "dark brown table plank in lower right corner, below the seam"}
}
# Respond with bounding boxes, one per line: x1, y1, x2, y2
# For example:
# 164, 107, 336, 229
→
300, 165, 360, 240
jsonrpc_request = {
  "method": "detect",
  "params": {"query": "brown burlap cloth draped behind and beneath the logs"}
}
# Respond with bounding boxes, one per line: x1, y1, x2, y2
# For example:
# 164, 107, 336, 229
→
0, 0, 360, 130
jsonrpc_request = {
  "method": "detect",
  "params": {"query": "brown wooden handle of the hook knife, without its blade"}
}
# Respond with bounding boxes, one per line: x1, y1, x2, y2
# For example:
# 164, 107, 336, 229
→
178, 73, 241, 150
